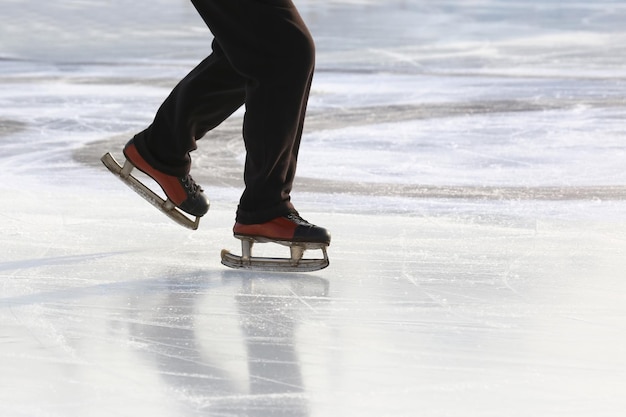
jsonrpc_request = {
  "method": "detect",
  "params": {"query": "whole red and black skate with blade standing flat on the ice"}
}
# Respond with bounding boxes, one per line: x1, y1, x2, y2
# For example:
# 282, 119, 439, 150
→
222, 213, 330, 272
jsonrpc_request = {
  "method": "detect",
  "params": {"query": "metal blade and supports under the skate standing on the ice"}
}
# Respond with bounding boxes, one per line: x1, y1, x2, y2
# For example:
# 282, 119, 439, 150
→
222, 236, 329, 272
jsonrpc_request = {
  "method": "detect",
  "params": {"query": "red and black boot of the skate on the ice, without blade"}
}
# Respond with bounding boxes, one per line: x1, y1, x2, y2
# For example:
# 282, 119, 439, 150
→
233, 213, 330, 246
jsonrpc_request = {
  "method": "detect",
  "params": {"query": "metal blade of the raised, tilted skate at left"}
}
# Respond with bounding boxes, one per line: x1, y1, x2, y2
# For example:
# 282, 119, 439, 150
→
100, 152, 200, 230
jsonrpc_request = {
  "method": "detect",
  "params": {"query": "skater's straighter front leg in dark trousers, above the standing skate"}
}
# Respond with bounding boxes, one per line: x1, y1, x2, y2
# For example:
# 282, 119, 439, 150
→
192, 0, 315, 224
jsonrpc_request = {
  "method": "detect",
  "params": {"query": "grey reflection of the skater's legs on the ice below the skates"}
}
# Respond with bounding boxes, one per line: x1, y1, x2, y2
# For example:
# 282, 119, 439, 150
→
122, 274, 329, 416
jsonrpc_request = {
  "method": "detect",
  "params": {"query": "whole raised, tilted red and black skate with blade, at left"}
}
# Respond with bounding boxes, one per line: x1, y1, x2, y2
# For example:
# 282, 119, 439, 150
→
101, 141, 209, 230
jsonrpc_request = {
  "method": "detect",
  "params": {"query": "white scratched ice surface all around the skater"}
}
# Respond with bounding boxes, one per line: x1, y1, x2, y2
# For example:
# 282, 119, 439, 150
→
0, 0, 626, 417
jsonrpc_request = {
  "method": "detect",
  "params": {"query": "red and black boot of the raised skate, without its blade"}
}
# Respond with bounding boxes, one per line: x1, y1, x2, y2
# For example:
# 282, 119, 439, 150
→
124, 140, 209, 217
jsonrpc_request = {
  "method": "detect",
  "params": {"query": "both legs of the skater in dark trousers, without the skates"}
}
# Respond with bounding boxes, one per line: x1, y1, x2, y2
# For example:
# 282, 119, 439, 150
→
133, 0, 315, 225
